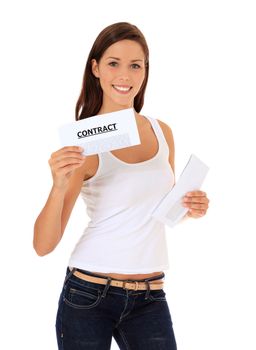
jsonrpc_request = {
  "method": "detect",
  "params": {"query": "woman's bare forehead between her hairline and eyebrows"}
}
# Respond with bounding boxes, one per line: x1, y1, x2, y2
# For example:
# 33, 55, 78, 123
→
102, 40, 145, 60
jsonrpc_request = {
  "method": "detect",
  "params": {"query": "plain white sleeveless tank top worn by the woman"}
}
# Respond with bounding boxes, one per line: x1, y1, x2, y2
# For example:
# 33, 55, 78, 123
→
69, 117, 174, 274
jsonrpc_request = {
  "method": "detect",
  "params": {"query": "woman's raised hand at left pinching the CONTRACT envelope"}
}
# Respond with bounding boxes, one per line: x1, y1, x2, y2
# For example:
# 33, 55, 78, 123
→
48, 146, 86, 189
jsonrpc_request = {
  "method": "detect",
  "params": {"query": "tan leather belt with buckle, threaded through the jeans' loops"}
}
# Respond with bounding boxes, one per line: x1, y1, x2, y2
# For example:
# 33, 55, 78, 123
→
73, 270, 164, 290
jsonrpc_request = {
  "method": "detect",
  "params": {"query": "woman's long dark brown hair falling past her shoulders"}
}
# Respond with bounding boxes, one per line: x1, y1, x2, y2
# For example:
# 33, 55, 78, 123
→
75, 22, 149, 120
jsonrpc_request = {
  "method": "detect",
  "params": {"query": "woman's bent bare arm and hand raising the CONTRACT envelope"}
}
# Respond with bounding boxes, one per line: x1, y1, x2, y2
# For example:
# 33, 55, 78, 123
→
33, 147, 86, 256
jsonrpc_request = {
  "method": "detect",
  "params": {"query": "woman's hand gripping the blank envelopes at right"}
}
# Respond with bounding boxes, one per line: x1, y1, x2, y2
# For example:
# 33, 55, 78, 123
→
183, 191, 209, 218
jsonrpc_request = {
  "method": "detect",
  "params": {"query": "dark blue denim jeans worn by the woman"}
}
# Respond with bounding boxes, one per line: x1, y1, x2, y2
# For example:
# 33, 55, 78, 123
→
56, 268, 177, 350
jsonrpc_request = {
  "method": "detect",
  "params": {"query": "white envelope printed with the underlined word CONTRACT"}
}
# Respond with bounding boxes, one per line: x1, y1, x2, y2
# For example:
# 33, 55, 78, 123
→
59, 108, 141, 155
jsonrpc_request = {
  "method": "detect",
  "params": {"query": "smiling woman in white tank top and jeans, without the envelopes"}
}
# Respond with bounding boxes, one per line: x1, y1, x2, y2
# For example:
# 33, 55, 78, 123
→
33, 22, 209, 350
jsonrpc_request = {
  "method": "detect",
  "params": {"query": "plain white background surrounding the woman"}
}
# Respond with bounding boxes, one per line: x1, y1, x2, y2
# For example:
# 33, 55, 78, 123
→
0, 0, 256, 350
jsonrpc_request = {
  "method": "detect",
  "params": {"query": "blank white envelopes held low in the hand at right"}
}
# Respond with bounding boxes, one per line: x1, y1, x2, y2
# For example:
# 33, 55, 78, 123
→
152, 154, 209, 227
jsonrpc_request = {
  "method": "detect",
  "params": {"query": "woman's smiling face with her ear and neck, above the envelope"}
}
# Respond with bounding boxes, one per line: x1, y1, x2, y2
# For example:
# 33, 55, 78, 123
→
92, 40, 145, 114
